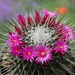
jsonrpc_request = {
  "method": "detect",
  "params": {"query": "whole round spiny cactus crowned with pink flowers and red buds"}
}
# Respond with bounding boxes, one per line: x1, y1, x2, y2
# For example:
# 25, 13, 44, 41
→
2, 9, 75, 75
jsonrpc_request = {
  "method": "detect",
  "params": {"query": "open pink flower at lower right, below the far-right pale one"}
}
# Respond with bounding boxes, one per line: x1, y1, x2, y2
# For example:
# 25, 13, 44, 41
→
55, 41, 69, 55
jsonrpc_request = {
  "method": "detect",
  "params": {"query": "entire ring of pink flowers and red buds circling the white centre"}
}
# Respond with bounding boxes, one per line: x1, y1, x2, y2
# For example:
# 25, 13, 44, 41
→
7, 9, 75, 64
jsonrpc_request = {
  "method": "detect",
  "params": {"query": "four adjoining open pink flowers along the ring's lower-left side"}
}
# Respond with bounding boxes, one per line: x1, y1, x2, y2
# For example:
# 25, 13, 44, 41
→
7, 33, 52, 64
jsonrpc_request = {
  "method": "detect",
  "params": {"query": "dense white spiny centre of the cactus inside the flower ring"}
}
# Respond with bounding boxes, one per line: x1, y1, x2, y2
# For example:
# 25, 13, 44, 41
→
27, 25, 55, 45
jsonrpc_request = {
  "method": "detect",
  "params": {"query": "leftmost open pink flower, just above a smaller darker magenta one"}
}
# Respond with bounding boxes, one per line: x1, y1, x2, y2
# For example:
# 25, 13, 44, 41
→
7, 33, 22, 46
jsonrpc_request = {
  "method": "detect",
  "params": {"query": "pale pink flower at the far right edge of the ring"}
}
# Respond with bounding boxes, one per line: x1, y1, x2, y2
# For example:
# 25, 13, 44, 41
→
62, 26, 75, 40
